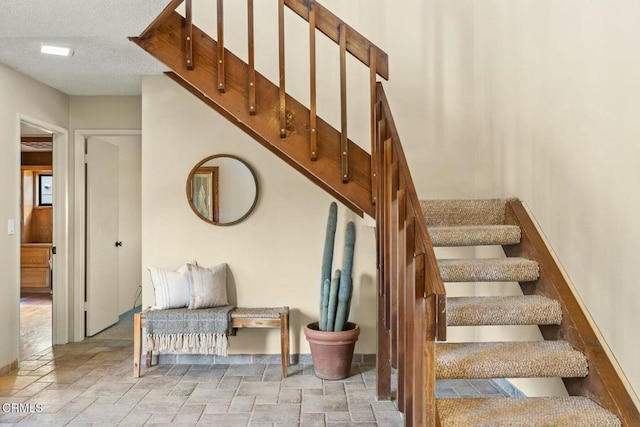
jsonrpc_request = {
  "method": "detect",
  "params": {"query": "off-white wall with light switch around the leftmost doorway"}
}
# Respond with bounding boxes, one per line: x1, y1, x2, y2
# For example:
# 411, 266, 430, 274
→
0, 64, 69, 367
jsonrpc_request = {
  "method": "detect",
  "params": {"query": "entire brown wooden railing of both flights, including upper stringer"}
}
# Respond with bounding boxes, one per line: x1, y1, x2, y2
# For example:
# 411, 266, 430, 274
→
131, 0, 446, 426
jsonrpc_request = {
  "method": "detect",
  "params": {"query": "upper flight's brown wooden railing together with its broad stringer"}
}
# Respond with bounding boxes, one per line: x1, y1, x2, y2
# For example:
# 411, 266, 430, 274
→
131, 0, 389, 216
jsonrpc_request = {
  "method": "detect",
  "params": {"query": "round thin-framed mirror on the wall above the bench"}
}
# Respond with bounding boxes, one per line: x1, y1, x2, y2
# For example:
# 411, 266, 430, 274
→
187, 154, 258, 225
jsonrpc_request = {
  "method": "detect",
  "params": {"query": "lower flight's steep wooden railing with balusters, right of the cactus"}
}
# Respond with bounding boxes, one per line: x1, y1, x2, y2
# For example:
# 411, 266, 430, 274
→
372, 83, 447, 426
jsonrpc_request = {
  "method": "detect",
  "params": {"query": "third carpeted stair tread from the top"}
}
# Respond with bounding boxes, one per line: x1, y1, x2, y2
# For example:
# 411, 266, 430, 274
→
438, 257, 540, 282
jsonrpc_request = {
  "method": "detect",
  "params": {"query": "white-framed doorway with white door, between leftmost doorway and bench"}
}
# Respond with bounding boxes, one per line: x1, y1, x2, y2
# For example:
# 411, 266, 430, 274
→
74, 129, 142, 340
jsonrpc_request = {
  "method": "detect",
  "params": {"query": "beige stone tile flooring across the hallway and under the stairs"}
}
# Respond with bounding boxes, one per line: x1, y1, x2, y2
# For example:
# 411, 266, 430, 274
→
0, 332, 504, 427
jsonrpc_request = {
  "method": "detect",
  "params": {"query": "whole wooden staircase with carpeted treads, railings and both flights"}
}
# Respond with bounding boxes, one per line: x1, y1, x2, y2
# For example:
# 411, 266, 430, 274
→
131, 0, 640, 426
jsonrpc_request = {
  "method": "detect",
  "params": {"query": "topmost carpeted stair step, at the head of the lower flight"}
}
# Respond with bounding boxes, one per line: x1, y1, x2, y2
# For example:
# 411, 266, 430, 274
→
420, 199, 508, 227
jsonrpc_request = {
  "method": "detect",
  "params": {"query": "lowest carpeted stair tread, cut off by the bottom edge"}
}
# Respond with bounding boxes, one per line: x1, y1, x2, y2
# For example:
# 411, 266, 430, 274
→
436, 396, 622, 427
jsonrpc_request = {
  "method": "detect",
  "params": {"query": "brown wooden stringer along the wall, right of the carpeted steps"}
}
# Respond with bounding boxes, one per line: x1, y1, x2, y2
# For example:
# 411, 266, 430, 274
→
503, 200, 640, 426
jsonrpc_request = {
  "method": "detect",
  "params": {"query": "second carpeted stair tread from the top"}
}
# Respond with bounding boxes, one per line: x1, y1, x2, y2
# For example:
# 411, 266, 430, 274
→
429, 225, 520, 246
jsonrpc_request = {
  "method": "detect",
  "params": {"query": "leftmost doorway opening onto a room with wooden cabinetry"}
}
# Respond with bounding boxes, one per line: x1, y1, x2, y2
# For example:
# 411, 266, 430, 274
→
15, 114, 71, 360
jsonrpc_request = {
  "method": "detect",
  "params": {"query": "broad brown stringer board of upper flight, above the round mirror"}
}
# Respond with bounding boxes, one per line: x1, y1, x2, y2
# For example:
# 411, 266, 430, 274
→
130, 12, 375, 217
